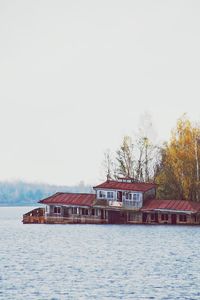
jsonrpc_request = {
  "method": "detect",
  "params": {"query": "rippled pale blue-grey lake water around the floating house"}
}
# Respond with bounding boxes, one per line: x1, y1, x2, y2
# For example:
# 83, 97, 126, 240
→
0, 207, 200, 300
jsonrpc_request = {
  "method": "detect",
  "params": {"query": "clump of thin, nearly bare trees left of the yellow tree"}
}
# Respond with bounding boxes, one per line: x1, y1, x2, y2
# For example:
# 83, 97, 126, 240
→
103, 113, 159, 182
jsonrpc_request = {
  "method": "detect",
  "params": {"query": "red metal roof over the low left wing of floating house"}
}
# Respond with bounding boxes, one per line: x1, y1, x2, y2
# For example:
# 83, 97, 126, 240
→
39, 193, 96, 206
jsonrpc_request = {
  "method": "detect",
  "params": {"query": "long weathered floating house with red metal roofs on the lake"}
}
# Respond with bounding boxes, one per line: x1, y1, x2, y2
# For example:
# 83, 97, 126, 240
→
23, 178, 200, 225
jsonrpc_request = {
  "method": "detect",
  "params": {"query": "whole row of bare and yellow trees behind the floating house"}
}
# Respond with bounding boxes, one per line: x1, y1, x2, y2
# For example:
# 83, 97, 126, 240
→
103, 115, 200, 201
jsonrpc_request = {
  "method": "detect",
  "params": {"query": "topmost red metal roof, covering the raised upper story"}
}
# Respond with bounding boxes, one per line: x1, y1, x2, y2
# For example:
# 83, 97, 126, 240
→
94, 180, 156, 192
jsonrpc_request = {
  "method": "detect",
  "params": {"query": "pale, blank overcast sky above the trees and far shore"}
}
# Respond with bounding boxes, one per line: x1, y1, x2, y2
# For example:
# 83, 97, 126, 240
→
0, 0, 200, 185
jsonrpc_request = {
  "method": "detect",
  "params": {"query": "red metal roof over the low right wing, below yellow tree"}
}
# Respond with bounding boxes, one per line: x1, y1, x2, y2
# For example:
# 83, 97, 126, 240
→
142, 199, 200, 212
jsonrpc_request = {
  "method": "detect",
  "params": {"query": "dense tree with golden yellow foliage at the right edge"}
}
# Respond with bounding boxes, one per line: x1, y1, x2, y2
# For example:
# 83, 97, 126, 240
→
156, 115, 200, 201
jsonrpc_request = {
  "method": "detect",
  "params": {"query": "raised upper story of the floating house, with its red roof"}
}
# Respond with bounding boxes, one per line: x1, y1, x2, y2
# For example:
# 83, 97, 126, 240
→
94, 178, 156, 209
